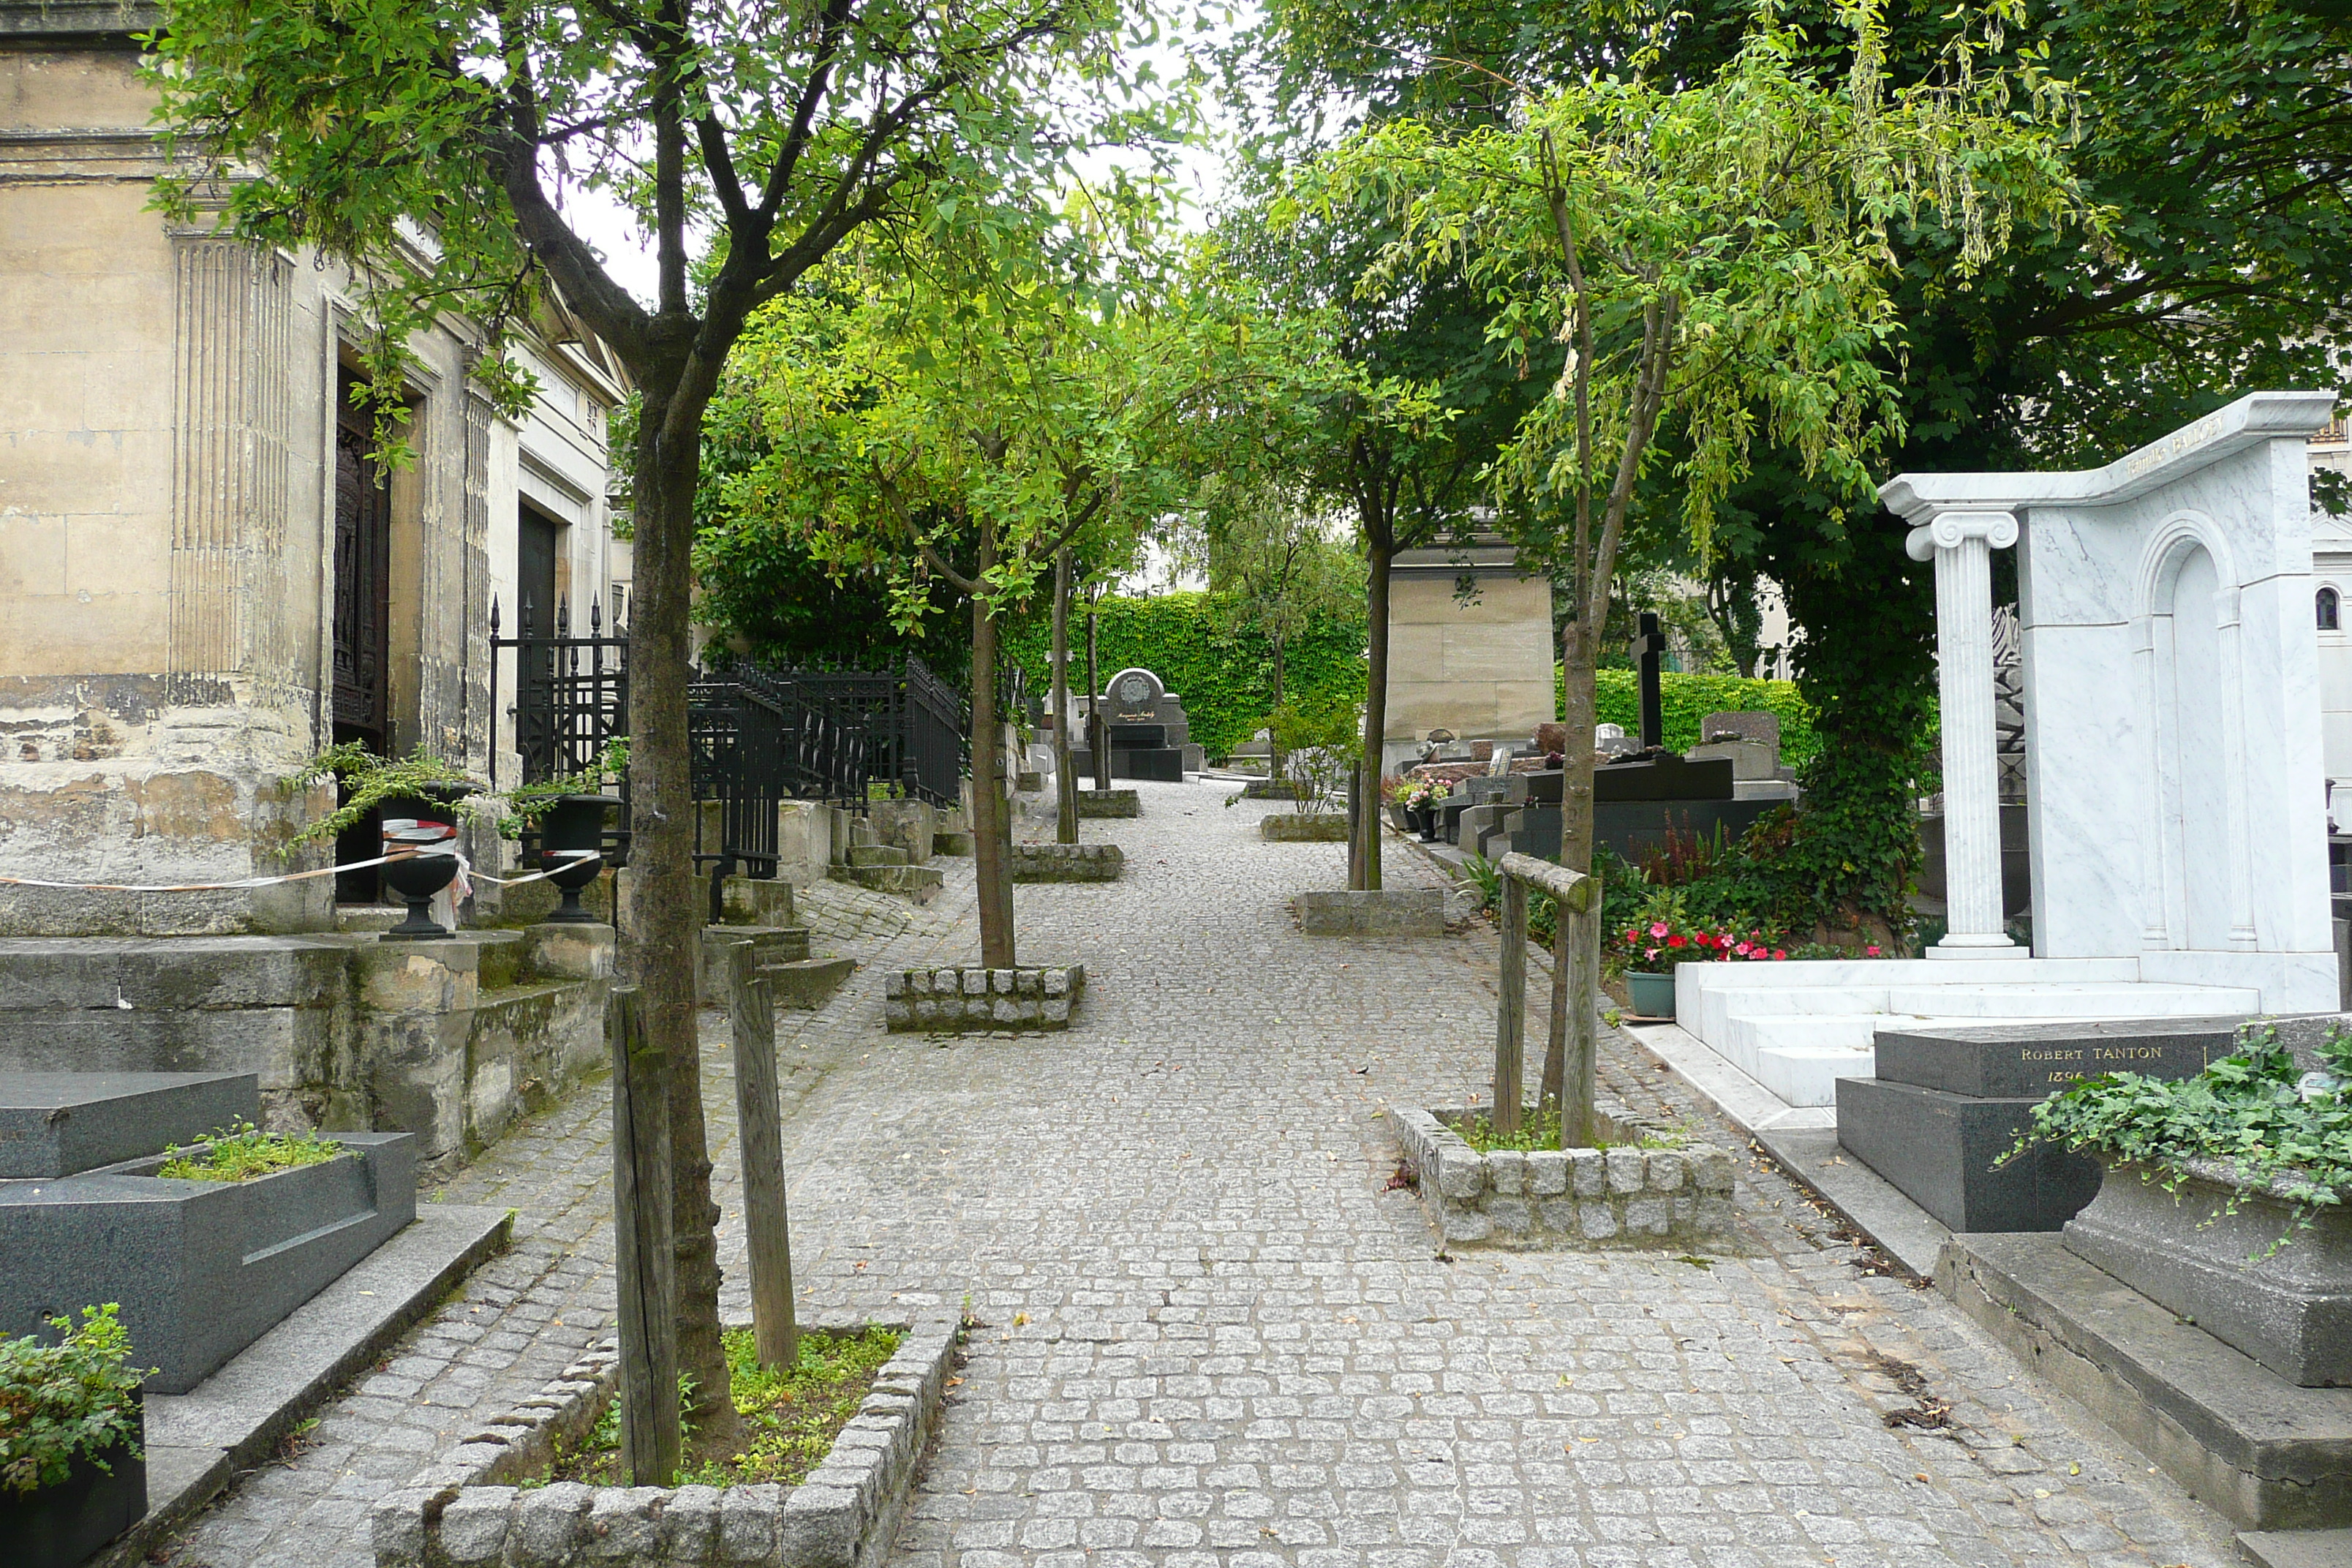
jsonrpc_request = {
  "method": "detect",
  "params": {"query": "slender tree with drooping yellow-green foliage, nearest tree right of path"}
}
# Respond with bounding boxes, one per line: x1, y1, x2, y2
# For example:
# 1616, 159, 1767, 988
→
1319, 4, 2072, 1090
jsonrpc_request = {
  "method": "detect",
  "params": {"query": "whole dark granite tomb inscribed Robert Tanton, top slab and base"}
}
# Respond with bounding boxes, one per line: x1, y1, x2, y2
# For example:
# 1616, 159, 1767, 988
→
1837, 1016, 2244, 1232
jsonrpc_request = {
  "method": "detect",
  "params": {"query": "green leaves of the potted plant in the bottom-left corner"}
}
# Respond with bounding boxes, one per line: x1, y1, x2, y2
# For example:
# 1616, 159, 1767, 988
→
0, 1303, 155, 1493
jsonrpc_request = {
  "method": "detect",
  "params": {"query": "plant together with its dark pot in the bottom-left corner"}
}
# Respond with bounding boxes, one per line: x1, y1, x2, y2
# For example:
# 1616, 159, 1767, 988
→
0, 1303, 148, 1568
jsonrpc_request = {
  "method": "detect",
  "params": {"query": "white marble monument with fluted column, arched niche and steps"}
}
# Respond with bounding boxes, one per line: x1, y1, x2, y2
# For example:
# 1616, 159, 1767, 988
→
1675, 393, 2338, 1107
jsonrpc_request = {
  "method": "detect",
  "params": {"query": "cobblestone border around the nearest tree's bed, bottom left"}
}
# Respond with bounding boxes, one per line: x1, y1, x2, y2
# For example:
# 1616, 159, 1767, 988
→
367, 1319, 962, 1568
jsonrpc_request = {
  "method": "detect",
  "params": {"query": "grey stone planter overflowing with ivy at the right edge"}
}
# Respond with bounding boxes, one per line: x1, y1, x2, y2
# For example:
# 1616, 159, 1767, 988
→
2011, 1025, 2352, 1387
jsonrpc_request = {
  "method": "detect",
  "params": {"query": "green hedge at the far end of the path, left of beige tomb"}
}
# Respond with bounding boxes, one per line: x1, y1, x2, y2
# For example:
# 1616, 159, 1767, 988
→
1004, 592, 1364, 757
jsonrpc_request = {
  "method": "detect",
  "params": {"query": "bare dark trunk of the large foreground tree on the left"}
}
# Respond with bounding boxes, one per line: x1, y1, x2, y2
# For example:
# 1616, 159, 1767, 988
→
621, 385, 741, 1446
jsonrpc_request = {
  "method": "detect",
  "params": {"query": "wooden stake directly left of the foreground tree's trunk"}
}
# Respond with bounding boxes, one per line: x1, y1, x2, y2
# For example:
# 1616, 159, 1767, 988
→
605, 985, 685, 1485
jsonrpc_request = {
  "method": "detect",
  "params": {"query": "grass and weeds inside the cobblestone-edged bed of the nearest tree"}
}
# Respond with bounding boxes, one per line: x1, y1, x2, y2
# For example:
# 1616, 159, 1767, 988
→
540, 1328, 899, 1485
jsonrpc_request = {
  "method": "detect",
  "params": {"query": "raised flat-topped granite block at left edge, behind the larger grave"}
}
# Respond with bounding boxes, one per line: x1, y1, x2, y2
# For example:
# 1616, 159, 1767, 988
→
0, 1072, 261, 1180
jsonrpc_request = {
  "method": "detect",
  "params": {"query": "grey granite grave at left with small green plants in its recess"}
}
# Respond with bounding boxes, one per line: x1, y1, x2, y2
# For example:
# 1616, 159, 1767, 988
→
0, 1133, 416, 1394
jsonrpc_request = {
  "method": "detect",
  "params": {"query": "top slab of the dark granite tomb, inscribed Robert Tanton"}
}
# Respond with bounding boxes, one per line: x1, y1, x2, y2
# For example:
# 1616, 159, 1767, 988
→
1877, 1016, 2244, 1100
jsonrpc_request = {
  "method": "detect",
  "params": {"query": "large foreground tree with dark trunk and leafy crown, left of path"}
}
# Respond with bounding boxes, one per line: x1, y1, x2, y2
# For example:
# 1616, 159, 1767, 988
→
151, 0, 1134, 1444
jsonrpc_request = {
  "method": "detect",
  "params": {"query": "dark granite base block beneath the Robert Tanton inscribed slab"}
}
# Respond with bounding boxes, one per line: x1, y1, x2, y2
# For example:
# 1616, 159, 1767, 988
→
1837, 1079, 2098, 1229
